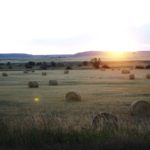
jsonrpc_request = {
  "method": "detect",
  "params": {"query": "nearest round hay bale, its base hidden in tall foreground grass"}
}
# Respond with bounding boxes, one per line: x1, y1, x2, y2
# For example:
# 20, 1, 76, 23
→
92, 112, 118, 130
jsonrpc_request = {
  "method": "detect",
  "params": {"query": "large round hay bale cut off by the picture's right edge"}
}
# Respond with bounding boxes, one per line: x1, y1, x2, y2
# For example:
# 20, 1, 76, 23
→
130, 100, 150, 117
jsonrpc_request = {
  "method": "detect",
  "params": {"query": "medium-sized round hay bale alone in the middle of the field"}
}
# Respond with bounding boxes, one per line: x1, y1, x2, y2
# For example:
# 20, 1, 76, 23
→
65, 92, 81, 101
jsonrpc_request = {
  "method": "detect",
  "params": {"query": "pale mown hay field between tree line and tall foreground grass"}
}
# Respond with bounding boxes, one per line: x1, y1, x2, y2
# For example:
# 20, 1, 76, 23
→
0, 69, 150, 127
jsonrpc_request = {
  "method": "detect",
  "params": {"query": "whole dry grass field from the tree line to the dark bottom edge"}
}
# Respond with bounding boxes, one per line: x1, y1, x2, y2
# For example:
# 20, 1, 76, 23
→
0, 69, 150, 150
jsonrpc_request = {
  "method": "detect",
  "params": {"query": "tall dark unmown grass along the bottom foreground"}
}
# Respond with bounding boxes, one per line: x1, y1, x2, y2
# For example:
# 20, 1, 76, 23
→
0, 116, 150, 150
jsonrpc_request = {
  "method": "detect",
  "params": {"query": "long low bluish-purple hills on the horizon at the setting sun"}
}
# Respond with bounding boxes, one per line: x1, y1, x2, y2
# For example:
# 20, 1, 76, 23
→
0, 51, 150, 60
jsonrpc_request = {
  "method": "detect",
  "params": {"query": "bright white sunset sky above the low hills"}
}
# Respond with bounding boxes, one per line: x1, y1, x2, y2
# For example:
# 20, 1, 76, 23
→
0, 0, 150, 54
